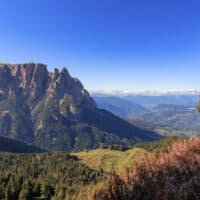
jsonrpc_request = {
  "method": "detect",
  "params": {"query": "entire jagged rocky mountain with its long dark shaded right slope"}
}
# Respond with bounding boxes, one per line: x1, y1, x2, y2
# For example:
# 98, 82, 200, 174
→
0, 63, 159, 151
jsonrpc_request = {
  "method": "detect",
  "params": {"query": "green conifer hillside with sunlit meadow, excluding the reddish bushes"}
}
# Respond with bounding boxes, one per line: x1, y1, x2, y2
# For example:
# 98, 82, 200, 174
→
0, 138, 180, 200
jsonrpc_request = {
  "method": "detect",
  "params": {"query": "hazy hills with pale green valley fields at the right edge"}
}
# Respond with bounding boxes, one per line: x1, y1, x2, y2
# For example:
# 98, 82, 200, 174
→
130, 105, 200, 136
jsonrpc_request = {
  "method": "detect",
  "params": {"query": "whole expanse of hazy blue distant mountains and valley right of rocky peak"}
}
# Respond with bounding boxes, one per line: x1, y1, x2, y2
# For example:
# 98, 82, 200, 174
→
94, 94, 200, 136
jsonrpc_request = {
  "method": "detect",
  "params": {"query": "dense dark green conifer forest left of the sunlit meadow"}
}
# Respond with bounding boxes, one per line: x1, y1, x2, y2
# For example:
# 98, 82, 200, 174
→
0, 153, 103, 200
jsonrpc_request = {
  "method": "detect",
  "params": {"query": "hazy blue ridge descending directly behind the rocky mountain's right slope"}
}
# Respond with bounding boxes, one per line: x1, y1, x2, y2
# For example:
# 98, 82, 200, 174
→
94, 96, 147, 118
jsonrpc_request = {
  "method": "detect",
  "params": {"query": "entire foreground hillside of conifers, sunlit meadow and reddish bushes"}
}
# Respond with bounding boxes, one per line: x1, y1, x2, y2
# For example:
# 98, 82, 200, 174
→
0, 137, 200, 200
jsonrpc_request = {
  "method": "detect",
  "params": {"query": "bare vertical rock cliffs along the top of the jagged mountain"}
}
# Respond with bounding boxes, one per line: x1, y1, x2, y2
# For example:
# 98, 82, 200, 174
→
0, 63, 96, 109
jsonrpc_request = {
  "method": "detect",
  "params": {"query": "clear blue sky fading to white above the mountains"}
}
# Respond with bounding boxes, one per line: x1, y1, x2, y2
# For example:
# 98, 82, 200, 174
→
0, 0, 200, 90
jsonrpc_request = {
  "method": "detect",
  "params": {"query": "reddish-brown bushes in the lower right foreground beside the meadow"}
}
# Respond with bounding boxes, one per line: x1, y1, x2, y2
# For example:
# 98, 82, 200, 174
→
92, 138, 200, 200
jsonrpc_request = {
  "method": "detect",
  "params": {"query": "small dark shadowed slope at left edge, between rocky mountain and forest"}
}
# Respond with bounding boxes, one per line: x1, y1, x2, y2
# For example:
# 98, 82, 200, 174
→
0, 136, 45, 153
